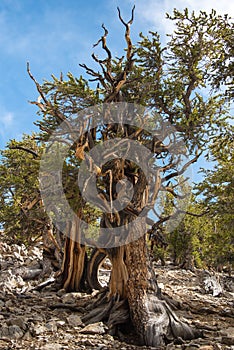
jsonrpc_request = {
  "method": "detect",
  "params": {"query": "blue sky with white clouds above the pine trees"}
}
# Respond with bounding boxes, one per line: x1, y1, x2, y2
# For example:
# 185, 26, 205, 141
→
0, 0, 234, 183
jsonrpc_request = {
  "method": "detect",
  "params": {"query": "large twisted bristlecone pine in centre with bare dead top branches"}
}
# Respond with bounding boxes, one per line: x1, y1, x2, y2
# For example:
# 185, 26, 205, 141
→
28, 9, 234, 346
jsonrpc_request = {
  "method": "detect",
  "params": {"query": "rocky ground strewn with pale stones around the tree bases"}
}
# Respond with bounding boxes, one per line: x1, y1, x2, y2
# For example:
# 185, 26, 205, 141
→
0, 243, 234, 350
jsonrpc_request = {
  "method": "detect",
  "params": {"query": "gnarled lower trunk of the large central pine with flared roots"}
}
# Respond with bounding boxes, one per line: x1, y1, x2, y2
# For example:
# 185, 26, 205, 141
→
83, 164, 195, 346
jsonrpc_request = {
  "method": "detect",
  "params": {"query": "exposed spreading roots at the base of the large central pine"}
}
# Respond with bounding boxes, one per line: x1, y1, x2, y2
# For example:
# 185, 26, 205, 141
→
82, 291, 201, 346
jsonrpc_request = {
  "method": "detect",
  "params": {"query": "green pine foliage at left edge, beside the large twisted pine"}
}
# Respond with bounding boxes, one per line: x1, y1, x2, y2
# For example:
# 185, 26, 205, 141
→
0, 135, 48, 243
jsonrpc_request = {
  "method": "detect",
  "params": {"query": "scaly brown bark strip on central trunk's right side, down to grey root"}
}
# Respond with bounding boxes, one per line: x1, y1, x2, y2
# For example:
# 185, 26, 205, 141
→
125, 223, 195, 346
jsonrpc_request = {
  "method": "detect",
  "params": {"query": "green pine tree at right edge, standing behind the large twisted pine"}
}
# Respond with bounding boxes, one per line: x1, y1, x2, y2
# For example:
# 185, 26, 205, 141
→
193, 124, 234, 273
